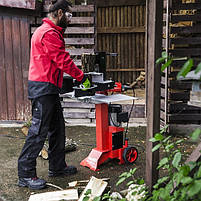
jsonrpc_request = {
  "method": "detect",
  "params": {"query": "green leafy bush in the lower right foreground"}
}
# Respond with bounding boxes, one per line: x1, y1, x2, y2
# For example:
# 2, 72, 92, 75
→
84, 126, 201, 201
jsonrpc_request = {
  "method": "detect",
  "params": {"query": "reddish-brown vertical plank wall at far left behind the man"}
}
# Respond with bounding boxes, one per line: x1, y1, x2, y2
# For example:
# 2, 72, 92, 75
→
0, 7, 30, 120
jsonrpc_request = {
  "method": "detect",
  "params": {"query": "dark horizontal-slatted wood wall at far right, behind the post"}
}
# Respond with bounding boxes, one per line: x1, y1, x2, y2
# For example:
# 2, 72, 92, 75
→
161, 0, 201, 124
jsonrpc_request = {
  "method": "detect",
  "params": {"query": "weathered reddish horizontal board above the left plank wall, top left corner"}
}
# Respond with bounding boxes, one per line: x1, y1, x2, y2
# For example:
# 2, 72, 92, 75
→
0, 0, 38, 10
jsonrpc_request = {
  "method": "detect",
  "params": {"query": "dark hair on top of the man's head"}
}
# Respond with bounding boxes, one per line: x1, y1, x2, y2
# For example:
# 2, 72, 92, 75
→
48, 0, 72, 17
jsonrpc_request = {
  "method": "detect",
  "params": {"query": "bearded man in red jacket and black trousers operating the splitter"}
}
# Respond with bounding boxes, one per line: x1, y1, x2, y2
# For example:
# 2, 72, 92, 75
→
18, 0, 90, 189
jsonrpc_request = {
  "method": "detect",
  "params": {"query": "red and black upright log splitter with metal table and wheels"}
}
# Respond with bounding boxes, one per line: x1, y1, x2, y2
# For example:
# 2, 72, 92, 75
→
74, 52, 138, 171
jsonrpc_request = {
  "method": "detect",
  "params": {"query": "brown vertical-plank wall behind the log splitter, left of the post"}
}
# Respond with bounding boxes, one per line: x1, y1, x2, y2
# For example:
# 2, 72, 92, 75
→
96, 0, 146, 84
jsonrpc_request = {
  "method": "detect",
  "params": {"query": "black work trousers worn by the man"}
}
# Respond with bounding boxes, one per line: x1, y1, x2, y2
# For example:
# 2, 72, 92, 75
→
18, 95, 66, 178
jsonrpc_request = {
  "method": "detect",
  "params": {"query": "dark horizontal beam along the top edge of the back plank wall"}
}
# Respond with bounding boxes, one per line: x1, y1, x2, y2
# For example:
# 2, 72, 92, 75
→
96, 0, 146, 7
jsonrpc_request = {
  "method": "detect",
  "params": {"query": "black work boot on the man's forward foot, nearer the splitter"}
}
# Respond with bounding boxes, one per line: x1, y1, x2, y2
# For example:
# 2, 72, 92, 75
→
48, 166, 77, 177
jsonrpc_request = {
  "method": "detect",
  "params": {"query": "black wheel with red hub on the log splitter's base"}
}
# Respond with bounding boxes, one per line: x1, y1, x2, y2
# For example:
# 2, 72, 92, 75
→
123, 147, 138, 164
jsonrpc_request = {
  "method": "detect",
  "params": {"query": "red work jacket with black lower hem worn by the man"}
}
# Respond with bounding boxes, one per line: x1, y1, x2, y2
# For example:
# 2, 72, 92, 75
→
28, 18, 84, 99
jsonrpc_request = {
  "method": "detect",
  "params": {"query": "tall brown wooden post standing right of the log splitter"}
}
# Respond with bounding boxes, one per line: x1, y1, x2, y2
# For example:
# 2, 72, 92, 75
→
146, 0, 163, 190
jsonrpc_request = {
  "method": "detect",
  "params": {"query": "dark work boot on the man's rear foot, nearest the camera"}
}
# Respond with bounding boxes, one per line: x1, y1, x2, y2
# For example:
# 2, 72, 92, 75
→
18, 177, 46, 190
